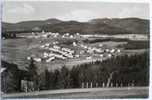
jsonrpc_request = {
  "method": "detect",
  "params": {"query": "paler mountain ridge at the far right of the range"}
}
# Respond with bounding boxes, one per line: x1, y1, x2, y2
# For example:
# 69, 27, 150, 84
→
90, 18, 150, 34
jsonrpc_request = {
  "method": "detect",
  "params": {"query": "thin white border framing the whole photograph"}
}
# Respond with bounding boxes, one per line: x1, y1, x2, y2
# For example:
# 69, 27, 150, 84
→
0, 0, 152, 100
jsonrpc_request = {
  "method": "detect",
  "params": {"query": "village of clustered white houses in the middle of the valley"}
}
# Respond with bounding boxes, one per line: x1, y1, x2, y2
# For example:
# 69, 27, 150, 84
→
27, 31, 121, 63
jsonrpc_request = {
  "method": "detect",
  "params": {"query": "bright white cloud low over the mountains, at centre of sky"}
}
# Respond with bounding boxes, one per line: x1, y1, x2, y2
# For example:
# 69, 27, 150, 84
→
57, 9, 99, 22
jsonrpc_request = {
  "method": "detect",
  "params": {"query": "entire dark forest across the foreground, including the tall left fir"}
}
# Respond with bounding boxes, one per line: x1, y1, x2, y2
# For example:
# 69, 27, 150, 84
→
1, 52, 149, 93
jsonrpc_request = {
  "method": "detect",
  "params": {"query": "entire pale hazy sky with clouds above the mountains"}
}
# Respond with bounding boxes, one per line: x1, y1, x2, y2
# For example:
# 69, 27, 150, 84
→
2, 1, 149, 23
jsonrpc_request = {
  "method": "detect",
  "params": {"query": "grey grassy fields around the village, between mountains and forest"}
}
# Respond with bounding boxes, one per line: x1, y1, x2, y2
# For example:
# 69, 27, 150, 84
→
2, 34, 149, 71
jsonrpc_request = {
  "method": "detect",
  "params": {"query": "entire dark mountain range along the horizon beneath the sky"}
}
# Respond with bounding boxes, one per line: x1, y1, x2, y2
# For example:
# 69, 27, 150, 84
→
2, 18, 149, 34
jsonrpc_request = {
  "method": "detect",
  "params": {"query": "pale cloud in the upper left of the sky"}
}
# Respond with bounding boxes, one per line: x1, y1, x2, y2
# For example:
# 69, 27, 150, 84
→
8, 3, 35, 15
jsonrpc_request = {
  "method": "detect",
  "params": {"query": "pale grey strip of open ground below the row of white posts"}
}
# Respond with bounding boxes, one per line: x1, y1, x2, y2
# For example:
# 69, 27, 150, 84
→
2, 87, 149, 99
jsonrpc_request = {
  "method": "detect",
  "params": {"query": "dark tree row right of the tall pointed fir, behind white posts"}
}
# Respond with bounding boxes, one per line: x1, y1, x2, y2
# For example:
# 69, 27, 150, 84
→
37, 53, 149, 89
